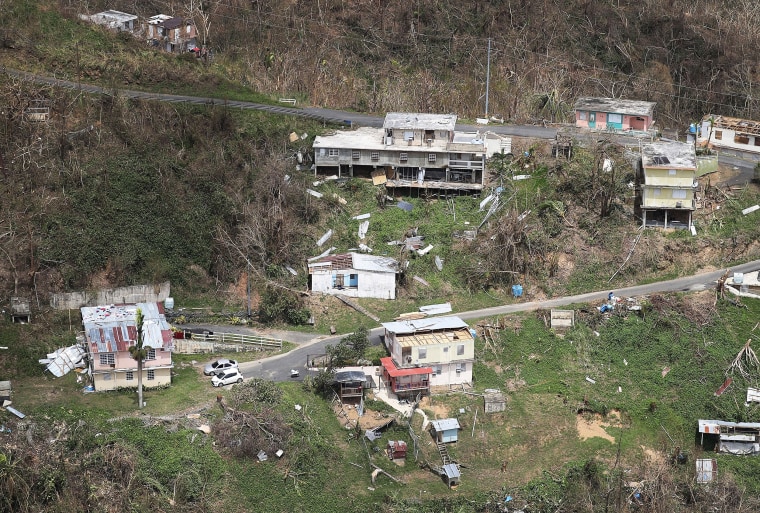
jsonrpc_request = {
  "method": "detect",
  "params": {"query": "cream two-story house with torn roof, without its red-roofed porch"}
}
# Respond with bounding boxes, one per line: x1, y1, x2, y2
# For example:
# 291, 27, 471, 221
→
383, 316, 475, 386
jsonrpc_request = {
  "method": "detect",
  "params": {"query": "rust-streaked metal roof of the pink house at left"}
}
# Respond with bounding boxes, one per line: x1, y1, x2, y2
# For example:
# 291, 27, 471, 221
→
81, 303, 172, 354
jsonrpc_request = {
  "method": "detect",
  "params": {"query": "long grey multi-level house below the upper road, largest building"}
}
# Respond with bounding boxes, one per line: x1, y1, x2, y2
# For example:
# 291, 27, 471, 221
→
314, 112, 512, 191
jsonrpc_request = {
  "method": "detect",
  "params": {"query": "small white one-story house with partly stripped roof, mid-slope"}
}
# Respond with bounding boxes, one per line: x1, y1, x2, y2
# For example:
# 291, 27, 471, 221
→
308, 253, 398, 299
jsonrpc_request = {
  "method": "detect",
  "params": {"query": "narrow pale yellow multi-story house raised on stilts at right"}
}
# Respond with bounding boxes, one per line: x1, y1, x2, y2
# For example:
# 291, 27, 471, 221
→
638, 141, 697, 229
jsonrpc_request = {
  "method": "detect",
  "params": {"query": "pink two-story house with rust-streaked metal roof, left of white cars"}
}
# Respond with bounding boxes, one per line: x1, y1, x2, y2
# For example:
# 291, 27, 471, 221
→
81, 303, 173, 391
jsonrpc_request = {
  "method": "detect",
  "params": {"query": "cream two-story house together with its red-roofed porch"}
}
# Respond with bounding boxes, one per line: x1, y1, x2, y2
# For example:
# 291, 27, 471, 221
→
380, 316, 475, 397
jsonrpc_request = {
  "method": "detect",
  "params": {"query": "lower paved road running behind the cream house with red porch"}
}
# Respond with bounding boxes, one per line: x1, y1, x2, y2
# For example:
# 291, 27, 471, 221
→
240, 260, 760, 381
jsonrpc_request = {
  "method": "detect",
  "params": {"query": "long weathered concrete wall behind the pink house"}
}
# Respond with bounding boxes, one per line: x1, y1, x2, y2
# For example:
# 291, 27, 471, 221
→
50, 281, 171, 310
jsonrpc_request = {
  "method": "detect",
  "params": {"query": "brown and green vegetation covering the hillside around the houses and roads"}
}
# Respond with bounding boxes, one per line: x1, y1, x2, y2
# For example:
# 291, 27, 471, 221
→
0, 0, 760, 513
